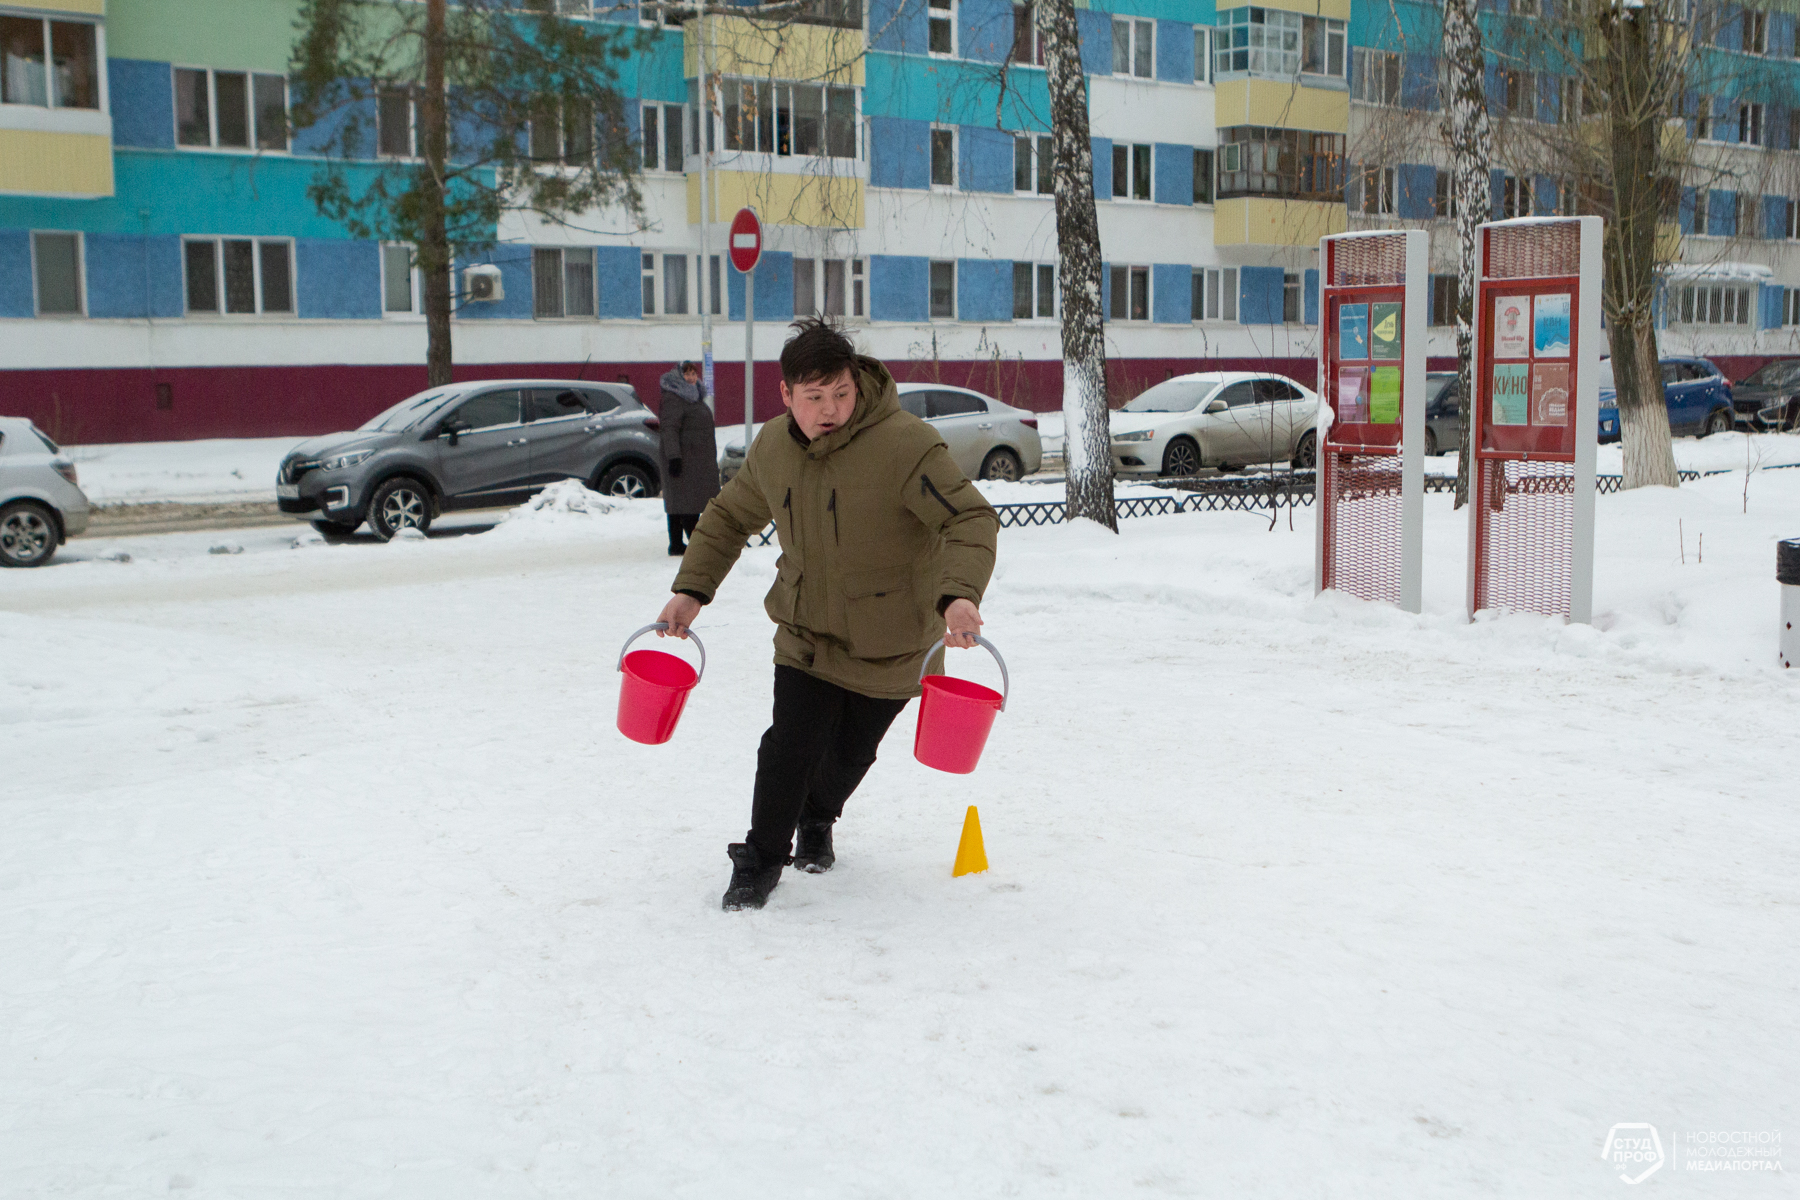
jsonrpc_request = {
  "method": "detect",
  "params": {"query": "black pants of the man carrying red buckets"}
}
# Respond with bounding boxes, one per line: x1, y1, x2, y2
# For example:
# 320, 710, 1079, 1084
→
745, 666, 905, 862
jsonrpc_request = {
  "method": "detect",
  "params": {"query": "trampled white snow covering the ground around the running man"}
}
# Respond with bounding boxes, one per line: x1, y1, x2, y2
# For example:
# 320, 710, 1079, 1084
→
0, 471, 1800, 1200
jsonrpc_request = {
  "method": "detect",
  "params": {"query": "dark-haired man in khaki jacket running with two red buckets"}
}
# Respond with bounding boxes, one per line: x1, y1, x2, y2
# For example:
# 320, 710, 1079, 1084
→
659, 320, 999, 910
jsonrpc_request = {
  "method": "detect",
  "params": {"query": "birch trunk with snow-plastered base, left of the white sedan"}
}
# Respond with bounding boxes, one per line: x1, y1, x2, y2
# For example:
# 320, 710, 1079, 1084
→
1035, 0, 1118, 533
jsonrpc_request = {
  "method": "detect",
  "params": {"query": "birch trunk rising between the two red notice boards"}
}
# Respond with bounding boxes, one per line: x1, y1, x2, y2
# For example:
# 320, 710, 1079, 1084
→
1444, 0, 1494, 507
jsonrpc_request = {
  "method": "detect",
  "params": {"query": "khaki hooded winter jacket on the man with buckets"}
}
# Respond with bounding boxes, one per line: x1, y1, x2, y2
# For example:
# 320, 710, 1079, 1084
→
673, 358, 999, 700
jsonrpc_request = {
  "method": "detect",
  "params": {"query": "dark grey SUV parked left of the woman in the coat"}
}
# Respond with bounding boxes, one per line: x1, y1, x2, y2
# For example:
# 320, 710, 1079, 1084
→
275, 380, 661, 542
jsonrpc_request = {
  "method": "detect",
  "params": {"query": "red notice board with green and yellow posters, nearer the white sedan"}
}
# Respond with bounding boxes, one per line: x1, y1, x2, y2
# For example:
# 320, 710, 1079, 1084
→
1314, 228, 1431, 612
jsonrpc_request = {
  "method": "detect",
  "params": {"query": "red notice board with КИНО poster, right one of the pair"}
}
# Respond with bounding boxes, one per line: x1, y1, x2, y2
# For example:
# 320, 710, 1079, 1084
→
1467, 216, 1602, 622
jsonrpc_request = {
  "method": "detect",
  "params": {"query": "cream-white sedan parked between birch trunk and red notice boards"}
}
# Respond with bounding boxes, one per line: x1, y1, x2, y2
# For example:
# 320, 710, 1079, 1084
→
1111, 371, 1319, 475
